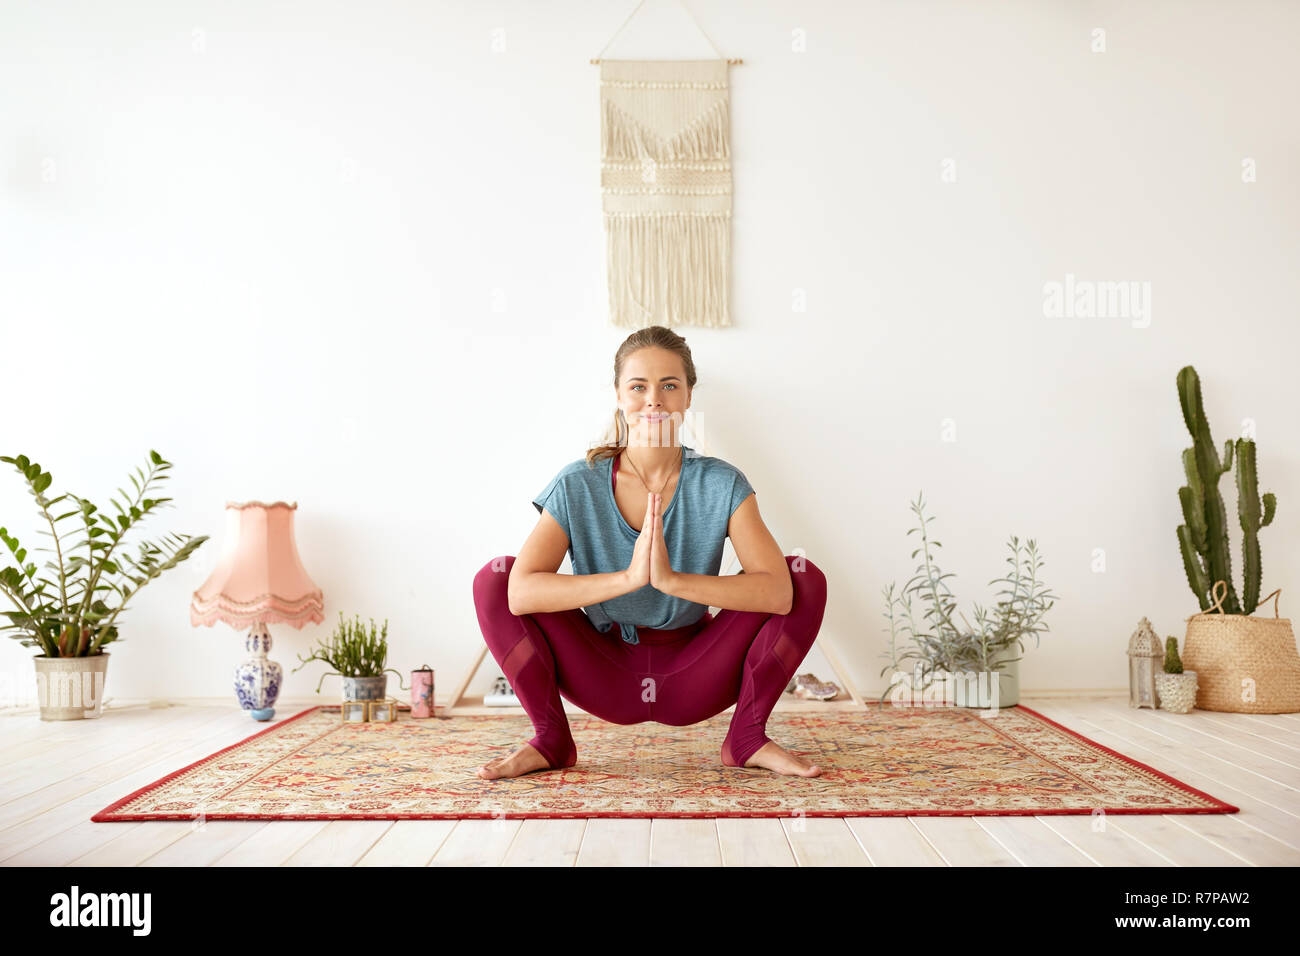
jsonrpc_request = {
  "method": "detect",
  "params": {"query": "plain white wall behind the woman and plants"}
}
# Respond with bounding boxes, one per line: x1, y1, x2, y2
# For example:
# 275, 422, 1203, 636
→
0, 0, 1300, 698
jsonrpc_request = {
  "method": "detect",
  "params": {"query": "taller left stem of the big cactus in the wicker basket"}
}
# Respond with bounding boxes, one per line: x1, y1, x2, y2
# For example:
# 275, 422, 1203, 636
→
1178, 365, 1237, 614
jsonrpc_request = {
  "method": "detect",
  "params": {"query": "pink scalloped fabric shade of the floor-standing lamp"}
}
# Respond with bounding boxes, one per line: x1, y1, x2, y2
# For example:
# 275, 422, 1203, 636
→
190, 501, 325, 630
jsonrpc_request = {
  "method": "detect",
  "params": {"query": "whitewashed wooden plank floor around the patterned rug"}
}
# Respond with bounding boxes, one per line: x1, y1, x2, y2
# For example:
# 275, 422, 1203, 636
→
0, 697, 1300, 866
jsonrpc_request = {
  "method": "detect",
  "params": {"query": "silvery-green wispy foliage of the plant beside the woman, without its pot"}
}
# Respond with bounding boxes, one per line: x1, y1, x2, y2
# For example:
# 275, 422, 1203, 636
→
880, 494, 1056, 701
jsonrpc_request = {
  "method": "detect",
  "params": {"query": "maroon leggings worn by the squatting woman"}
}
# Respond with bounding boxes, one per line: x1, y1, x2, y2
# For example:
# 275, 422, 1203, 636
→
475, 554, 826, 767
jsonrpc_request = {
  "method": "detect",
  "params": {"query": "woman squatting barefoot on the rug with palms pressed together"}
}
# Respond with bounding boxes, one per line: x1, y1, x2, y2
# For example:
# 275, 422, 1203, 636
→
475, 325, 826, 780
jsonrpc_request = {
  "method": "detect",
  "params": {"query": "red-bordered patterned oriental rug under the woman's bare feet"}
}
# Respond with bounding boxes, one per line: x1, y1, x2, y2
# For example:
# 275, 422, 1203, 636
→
91, 705, 1238, 822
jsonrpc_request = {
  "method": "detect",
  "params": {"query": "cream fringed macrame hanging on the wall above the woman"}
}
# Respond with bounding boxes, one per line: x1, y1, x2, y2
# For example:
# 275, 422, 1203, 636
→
592, 0, 741, 329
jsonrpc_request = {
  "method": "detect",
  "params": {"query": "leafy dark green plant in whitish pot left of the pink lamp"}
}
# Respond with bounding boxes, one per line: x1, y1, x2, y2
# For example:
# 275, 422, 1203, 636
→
0, 451, 208, 721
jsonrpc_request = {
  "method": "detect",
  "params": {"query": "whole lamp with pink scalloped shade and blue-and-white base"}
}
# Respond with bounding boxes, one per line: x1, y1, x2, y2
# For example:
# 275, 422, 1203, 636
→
190, 501, 325, 721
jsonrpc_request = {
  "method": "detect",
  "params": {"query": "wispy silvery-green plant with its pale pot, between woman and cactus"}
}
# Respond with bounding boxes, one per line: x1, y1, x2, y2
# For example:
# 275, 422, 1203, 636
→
880, 494, 1056, 708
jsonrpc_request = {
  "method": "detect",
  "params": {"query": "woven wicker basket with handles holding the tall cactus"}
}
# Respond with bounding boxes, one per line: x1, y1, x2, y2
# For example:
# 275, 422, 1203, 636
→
1183, 581, 1300, 714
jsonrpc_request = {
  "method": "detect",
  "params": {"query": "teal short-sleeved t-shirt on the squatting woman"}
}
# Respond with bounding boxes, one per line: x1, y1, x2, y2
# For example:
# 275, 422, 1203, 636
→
533, 445, 754, 644
